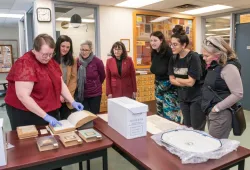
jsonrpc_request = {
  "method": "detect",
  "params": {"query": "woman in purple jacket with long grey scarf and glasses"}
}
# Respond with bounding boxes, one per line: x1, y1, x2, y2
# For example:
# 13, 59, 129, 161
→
76, 40, 106, 114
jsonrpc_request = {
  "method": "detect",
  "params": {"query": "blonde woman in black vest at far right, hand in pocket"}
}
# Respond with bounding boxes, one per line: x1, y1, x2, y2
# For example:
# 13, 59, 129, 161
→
201, 36, 243, 139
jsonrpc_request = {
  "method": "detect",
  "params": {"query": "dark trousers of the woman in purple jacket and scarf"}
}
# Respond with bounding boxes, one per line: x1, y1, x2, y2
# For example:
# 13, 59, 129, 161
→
83, 96, 102, 114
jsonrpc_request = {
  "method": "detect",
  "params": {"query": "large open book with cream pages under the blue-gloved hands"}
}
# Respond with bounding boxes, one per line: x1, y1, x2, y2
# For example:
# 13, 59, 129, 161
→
49, 110, 97, 134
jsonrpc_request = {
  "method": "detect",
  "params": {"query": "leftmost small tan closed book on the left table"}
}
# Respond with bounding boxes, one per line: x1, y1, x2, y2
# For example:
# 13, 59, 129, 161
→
17, 125, 38, 139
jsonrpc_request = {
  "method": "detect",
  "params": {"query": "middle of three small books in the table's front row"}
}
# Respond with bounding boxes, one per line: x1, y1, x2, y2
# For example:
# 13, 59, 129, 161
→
59, 132, 82, 147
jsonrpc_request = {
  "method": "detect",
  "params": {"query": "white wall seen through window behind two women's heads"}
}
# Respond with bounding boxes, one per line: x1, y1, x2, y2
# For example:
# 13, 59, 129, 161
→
56, 22, 95, 57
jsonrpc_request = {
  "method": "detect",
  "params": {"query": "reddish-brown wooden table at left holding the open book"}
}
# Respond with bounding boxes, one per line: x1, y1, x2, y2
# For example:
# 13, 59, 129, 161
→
0, 131, 113, 170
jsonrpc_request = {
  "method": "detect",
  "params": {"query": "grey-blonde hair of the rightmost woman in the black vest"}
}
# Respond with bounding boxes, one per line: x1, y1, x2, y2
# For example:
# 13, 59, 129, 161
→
202, 36, 237, 66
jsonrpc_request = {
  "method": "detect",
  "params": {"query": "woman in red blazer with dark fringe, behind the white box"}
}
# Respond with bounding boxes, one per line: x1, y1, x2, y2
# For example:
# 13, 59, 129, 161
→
106, 41, 137, 99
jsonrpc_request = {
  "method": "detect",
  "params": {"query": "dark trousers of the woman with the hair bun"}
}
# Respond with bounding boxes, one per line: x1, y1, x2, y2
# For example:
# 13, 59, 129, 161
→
180, 97, 206, 130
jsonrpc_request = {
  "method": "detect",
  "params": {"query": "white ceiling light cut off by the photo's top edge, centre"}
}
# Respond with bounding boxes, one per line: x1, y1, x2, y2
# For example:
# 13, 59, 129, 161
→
115, 0, 163, 8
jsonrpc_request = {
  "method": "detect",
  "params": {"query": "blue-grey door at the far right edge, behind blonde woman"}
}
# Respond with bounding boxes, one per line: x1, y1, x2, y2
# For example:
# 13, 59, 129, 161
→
235, 23, 250, 110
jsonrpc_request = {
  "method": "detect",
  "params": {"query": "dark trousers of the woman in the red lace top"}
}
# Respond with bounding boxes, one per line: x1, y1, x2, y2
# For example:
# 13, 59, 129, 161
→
6, 104, 59, 130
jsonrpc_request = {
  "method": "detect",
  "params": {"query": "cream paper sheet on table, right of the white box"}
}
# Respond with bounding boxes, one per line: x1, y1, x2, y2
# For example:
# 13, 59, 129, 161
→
147, 115, 180, 134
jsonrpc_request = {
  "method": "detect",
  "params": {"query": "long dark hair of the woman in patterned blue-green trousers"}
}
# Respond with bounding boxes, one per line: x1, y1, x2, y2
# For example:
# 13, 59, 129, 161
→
150, 31, 170, 57
